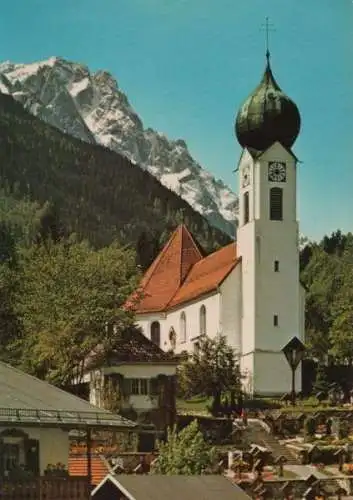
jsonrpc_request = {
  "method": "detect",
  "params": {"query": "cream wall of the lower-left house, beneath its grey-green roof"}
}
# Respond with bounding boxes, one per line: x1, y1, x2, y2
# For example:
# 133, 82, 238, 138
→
0, 427, 69, 474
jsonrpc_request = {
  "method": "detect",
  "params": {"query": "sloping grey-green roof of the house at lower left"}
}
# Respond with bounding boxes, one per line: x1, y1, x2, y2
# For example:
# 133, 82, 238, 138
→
0, 362, 137, 429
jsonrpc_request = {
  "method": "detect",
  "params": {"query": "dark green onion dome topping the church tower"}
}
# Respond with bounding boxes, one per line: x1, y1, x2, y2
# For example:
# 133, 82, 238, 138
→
235, 52, 300, 151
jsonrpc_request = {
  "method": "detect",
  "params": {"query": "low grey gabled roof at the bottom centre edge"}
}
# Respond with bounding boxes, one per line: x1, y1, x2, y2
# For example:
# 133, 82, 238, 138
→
92, 474, 250, 500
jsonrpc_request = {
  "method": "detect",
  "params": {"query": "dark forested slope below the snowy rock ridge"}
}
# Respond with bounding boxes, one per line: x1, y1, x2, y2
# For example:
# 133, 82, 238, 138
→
0, 94, 229, 267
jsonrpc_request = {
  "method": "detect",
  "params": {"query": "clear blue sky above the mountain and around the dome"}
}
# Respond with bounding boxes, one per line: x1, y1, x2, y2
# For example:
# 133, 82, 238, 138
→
0, 0, 353, 239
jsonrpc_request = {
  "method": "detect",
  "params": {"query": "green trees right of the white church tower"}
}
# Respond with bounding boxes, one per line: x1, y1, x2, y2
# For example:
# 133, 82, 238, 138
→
301, 231, 353, 365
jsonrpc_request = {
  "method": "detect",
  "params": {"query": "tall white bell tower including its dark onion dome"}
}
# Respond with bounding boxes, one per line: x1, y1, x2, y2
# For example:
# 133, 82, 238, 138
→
235, 51, 304, 395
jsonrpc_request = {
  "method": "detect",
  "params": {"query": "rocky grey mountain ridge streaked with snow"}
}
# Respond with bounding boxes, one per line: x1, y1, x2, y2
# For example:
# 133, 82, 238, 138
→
0, 57, 238, 235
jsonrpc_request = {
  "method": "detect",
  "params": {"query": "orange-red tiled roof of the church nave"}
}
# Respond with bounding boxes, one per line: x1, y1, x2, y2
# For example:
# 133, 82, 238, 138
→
130, 225, 240, 314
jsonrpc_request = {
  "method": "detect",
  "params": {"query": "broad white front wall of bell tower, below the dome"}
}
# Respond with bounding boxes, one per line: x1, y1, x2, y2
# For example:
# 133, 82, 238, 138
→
255, 143, 301, 350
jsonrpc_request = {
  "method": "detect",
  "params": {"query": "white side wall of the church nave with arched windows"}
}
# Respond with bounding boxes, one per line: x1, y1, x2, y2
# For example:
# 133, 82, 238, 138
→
162, 292, 220, 354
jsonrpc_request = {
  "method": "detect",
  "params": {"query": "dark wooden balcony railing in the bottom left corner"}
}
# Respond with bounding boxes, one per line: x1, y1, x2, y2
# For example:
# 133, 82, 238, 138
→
0, 477, 90, 500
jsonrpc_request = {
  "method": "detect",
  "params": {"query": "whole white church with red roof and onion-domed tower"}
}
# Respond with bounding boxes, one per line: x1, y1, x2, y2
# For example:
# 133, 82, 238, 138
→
129, 51, 305, 395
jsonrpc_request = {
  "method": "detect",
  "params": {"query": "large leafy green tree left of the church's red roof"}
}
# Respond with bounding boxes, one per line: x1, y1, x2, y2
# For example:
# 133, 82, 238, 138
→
14, 236, 138, 384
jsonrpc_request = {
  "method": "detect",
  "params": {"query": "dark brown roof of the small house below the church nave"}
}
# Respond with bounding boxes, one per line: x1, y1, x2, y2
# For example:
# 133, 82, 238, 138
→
86, 327, 178, 368
